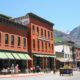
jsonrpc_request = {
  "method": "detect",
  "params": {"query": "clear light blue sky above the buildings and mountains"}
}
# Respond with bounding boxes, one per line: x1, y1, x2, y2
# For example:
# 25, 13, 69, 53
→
0, 0, 80, 33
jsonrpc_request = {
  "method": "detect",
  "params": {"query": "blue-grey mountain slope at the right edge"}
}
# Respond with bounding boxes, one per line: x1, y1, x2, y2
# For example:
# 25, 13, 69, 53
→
69, 26, 80, 45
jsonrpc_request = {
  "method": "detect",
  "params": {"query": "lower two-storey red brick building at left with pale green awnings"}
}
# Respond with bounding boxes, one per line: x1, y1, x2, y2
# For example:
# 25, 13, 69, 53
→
0, 15, 30, 70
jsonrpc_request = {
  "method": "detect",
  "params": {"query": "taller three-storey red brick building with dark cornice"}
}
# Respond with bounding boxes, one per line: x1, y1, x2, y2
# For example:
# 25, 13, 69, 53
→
14, 13, 54, 69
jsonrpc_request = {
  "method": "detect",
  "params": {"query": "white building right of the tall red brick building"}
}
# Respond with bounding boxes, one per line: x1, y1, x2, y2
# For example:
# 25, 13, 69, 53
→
54, 41, 73, 68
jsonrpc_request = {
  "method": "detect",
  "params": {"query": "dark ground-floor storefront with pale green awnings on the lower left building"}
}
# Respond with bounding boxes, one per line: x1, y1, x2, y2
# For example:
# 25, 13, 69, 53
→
0, 51, 31, 72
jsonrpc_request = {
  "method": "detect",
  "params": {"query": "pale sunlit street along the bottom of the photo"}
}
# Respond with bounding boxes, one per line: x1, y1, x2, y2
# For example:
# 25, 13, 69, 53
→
0, 71, 80, 80
